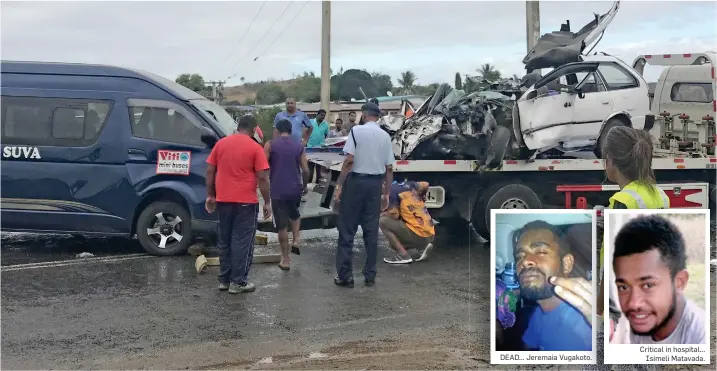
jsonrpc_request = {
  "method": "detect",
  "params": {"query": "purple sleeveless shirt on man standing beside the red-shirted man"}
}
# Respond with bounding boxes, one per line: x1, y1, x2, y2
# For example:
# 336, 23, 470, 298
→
269, 137, 304, 201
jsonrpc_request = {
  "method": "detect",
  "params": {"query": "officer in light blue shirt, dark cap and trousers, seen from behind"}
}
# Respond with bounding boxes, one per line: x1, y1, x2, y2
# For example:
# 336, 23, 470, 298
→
334, 103, 394, 287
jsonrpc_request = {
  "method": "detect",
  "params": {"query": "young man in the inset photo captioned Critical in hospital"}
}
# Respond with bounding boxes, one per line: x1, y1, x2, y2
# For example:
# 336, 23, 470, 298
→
613, 215, 707, 344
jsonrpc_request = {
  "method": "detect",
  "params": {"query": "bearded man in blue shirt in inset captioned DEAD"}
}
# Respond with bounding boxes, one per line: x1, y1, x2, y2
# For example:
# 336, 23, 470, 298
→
513, 221, 593, 352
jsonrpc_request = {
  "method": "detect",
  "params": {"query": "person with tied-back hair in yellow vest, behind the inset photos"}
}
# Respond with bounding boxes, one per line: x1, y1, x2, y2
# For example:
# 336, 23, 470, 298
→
597, 126, 670, 369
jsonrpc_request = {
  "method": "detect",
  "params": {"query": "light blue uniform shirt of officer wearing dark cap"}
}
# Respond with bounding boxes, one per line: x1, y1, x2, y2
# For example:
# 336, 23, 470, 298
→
344, 121, 395, 175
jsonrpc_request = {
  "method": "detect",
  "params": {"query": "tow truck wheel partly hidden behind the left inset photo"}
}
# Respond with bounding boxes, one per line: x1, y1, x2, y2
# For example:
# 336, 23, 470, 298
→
472, 184, 543, 240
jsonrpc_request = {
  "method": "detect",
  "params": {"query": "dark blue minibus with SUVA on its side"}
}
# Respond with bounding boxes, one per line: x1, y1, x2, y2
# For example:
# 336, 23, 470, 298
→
0, 61, 241, 255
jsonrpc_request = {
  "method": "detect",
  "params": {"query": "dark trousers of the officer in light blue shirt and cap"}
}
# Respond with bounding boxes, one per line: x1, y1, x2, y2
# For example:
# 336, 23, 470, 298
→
336, 173, 383, 280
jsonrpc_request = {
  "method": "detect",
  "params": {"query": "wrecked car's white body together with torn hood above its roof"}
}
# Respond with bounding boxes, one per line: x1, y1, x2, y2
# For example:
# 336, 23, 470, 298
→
513, 1, 654, 157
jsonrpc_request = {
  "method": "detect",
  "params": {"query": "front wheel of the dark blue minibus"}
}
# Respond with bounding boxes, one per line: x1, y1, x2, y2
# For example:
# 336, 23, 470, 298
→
135, 201, 192, 256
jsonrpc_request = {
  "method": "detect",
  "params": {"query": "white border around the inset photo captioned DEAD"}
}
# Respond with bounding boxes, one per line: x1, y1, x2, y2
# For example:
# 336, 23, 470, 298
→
490, 209, 599, 365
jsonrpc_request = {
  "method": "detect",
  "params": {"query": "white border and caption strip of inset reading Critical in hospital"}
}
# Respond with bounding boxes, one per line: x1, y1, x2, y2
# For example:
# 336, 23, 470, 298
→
603, 209, 712, 365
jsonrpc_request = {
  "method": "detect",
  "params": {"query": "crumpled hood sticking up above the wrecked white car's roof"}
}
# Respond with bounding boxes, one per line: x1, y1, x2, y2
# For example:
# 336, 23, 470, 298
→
523, 1, 620, 73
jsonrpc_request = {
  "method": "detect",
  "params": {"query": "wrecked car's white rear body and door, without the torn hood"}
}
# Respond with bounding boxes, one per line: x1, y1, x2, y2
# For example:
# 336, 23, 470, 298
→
513, 55, 654, 156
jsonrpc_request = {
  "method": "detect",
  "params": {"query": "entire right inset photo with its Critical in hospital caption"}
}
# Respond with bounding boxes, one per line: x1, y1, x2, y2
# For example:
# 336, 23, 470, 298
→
605, 209, 710, 364
